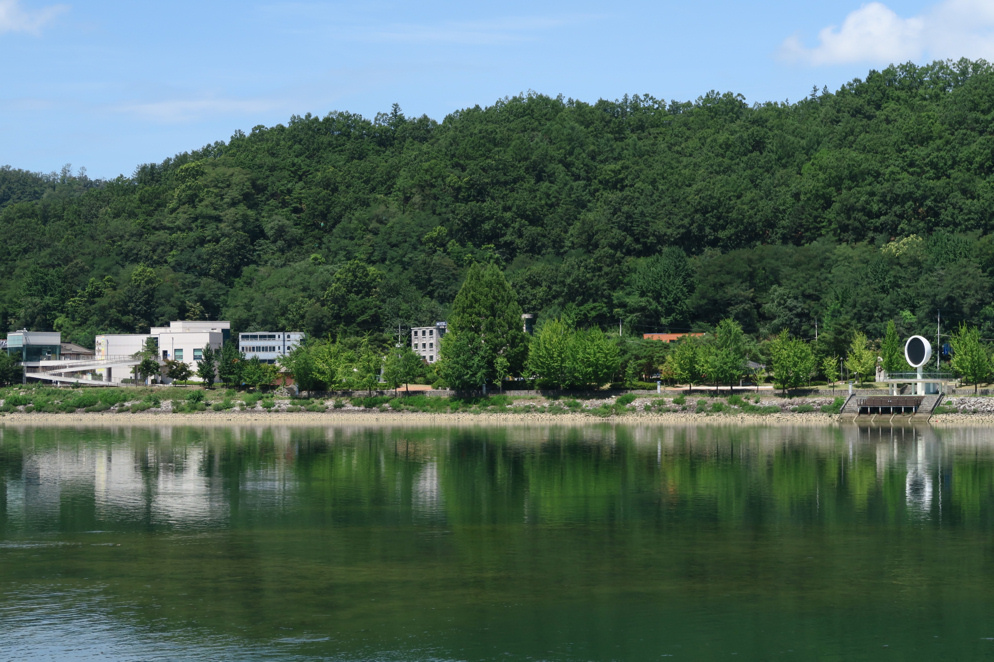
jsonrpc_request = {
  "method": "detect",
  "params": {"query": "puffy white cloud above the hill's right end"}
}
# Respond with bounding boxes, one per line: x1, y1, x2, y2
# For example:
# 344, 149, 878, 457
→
780, 0, 994, 65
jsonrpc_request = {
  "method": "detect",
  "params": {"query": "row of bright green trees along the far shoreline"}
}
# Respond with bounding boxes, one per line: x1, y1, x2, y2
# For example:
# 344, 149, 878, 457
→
266, 264, 994, 395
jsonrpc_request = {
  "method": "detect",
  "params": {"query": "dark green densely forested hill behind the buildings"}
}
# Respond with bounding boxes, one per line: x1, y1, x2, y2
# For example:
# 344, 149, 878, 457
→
0, 60, 994, 358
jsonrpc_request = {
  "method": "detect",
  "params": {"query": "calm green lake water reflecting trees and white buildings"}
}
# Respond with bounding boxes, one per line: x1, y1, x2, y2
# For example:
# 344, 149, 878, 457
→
0, 424, 994, 660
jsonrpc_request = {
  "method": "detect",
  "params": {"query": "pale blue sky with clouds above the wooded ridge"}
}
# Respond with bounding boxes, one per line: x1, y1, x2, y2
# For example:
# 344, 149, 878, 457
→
0, 0, 994, 178
